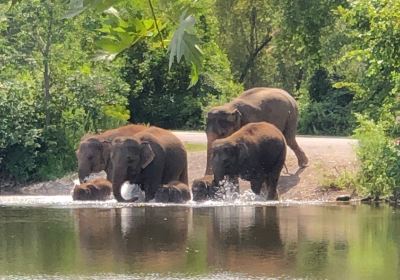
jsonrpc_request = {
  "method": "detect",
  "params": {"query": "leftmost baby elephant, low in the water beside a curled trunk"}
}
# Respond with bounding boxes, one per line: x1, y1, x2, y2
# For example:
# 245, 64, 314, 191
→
72, 178, 112, 200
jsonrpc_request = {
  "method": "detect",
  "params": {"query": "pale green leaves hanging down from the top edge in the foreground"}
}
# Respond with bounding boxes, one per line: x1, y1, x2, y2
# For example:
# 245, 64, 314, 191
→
65, 0, 203, 86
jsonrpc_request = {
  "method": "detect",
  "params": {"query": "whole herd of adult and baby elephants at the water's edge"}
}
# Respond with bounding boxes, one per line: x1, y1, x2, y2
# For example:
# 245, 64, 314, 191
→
72, 88, 308, 203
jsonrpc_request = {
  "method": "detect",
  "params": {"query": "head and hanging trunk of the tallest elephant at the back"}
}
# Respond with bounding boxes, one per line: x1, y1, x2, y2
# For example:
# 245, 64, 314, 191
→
206, 106, 242, 175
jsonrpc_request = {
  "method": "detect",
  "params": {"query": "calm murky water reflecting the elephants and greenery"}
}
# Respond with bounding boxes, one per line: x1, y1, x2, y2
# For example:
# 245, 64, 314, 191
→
0, 199, 400, 279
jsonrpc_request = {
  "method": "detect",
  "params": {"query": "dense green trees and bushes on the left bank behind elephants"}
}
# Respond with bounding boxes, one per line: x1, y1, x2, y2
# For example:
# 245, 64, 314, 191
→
0, 1, 129, 181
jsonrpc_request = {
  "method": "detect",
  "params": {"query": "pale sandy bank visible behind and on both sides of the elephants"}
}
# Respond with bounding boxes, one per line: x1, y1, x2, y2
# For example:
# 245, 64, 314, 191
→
2, 131, 357, 201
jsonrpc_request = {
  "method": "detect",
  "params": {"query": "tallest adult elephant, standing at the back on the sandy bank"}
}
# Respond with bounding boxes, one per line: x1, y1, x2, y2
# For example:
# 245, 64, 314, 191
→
205, 88, 308, 175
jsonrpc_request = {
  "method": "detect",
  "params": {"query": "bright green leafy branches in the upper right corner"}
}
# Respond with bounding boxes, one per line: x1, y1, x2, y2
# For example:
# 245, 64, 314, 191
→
338, 0, 400, 120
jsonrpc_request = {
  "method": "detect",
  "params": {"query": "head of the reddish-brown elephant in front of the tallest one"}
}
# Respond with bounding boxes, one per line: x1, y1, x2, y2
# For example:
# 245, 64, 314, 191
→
212, 139, 248, 183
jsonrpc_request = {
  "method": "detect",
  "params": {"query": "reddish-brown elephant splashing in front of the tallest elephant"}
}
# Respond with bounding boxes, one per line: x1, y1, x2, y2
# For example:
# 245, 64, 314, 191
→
212, 122, 286, 200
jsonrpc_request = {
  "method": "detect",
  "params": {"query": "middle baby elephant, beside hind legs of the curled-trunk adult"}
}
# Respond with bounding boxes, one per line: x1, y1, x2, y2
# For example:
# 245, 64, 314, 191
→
155, 181, 190, 203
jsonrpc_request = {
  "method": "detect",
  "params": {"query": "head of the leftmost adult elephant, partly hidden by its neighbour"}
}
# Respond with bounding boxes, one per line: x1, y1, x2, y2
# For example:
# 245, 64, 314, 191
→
76, 138, 111, 183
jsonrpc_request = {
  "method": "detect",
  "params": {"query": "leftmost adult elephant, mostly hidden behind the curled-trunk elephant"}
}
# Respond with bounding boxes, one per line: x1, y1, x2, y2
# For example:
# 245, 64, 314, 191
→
76, 124, 147, 183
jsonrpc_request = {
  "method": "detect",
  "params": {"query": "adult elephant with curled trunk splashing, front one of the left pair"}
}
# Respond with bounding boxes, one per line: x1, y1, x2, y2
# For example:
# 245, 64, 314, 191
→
111, 126, 188, 202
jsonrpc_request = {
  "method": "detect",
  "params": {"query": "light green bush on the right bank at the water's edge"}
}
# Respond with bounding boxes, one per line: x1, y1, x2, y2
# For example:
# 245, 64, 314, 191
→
355, 115, 400, 197
